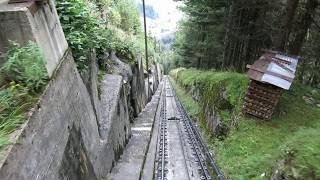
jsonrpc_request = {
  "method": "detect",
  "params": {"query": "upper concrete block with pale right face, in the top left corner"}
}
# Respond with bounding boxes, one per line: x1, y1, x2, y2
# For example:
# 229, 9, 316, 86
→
0, 0, 68, 76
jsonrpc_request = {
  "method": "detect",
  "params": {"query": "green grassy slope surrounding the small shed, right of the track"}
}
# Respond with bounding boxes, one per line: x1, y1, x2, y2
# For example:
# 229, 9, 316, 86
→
171, 69, 320, 179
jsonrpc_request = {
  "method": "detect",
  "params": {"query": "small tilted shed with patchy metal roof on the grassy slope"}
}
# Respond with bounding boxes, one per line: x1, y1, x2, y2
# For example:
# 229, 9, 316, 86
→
243, 50, 299, 120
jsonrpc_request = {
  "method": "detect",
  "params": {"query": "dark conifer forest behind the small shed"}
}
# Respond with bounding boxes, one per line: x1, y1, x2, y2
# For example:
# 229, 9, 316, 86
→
171, 0, 320, 86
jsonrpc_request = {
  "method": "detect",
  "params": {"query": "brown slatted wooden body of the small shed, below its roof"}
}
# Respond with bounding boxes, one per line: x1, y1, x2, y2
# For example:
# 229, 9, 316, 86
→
243, 80, 282, 120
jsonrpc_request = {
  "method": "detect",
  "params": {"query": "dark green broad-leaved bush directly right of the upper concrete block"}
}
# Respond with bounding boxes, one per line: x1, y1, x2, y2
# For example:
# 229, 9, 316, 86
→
56, 0, 111, 70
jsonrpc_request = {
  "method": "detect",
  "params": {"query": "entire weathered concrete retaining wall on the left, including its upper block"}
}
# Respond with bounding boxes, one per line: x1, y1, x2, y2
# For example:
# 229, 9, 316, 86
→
0, 0, 164, 180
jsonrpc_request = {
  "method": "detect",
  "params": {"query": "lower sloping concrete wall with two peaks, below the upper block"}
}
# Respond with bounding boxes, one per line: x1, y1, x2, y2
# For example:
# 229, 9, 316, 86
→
0, 50, 130, 180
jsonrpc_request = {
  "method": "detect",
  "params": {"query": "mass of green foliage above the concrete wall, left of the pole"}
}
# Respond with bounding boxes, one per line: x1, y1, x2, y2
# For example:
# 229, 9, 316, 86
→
56, 0, 162, 71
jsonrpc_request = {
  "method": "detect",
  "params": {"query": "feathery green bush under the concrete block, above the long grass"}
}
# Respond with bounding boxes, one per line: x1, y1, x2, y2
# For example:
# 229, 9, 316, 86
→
0, 42, 48, 92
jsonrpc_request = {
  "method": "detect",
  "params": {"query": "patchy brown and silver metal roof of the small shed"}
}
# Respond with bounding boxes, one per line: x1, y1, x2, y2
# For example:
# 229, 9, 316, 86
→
247, 51, 299, 90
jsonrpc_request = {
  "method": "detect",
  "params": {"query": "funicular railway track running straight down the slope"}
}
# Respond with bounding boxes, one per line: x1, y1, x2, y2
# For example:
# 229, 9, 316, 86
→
155, 78, 224, 180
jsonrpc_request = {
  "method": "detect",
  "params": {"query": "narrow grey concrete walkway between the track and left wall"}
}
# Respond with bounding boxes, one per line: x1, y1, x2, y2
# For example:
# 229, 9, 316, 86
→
108, 82, 162, 180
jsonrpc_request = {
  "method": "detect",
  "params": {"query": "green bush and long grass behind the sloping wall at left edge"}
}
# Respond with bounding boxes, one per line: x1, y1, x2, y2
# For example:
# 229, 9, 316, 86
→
0, 42, 48, 148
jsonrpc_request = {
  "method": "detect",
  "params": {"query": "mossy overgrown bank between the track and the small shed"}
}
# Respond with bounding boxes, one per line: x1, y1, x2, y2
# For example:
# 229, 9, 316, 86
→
170, 68, 249, 131
